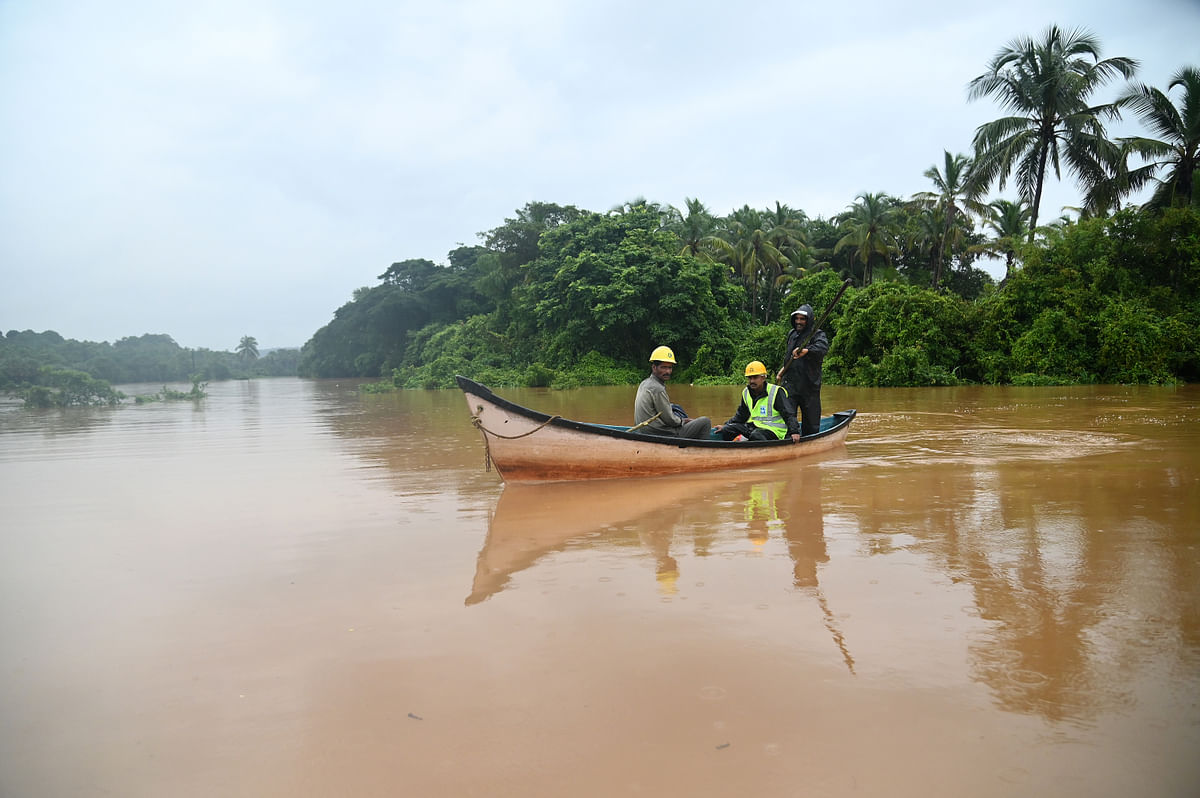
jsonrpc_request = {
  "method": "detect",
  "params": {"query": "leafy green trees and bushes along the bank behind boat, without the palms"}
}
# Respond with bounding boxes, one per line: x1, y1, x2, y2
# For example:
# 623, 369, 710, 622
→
326, 204, 1200, 389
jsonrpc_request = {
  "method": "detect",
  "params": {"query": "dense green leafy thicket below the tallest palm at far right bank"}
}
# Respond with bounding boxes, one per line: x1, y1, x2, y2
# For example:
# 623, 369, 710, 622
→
973, 209, 1200, 383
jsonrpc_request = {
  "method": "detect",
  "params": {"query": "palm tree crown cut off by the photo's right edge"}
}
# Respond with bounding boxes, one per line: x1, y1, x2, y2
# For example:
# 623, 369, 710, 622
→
1117, 66, 1200, 208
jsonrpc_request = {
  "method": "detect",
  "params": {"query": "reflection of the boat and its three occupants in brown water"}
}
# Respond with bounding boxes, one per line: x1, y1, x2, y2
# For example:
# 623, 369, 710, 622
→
466, 455, 854, 672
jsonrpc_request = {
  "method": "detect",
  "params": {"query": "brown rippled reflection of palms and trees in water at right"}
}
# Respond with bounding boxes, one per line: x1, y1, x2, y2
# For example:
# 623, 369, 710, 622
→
840, 436, 1200, 724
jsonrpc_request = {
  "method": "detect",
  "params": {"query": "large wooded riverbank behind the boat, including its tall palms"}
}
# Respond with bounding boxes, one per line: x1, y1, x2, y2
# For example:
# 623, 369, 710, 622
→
300, 26, 1200, 388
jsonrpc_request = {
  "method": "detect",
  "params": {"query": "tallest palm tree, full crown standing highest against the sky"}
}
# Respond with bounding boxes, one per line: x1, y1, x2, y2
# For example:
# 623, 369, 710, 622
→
967, 25, 1138, 239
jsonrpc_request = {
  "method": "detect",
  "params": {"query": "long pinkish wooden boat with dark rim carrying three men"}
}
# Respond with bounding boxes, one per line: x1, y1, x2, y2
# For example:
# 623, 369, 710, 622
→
456, 377, 857, 482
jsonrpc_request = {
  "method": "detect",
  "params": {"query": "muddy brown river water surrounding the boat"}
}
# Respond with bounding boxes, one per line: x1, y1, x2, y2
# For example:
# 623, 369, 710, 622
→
0, 379, 1200, 798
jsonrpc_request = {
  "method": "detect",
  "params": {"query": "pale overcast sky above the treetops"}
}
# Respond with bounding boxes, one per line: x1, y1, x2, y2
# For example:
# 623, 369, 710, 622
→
0, 0, 1200, 349
